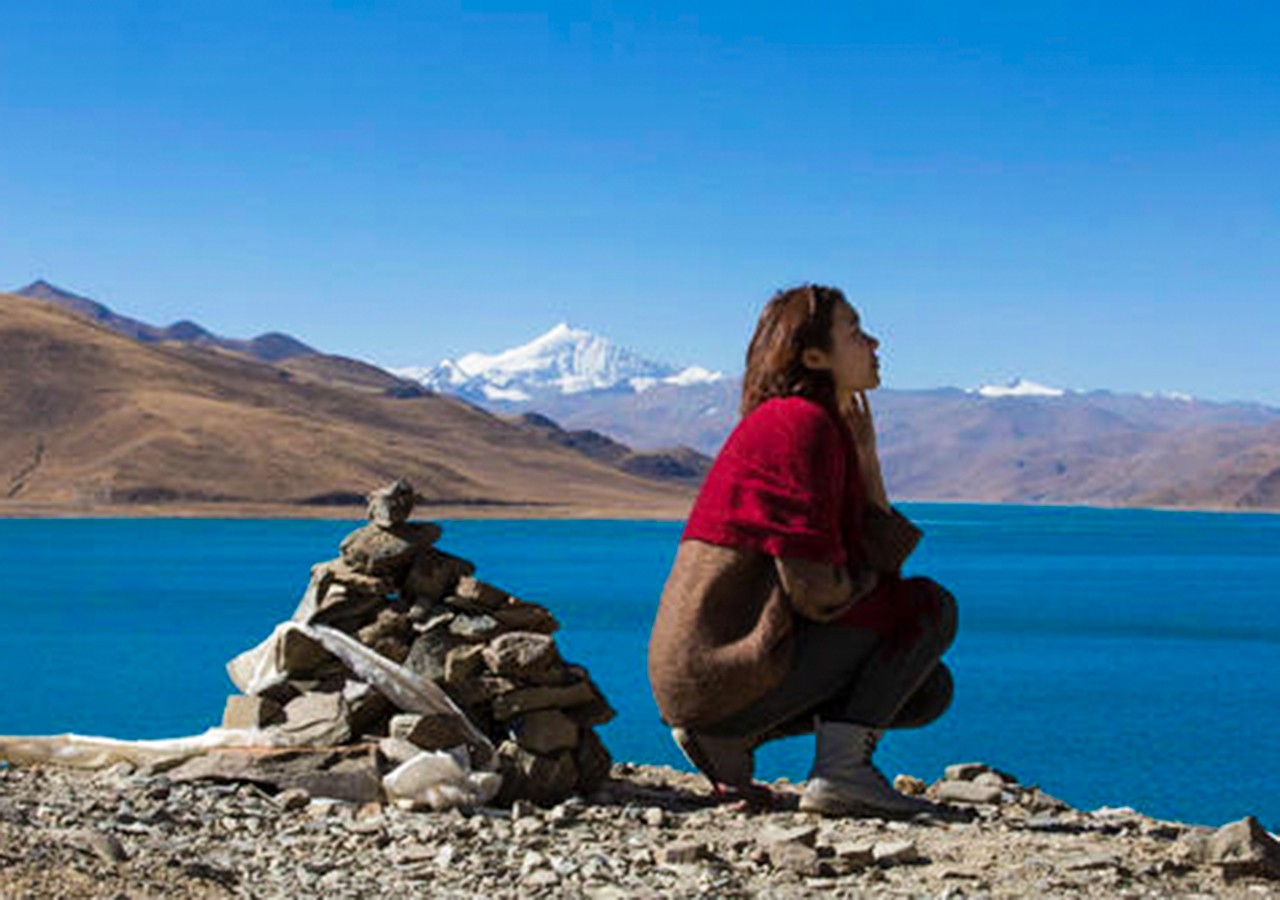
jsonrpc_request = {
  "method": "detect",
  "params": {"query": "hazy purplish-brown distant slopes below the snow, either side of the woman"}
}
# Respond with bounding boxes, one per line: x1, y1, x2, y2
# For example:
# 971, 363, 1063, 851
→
512, 379, 1280, 510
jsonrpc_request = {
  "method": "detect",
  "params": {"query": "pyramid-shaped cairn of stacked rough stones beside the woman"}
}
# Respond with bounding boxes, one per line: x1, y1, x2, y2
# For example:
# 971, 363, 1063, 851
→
215, 480, 614, 805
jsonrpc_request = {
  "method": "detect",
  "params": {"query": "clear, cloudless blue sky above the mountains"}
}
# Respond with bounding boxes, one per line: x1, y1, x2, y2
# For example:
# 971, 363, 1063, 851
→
0, 0, 1280, 405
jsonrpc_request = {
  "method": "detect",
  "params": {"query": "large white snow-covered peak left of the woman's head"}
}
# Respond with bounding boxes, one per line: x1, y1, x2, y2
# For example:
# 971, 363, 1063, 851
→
392, 323, 724, 403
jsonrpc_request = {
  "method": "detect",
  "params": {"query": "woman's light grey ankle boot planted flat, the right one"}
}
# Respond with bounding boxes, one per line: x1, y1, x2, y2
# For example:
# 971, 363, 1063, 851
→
800, 719, 938, 818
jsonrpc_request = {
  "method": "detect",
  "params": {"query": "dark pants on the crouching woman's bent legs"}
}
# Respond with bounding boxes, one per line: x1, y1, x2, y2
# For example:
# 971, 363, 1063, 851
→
699, 577, 956, 743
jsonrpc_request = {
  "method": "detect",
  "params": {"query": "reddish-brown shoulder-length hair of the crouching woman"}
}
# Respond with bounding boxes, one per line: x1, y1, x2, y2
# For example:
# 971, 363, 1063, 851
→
740, 284, 849, 416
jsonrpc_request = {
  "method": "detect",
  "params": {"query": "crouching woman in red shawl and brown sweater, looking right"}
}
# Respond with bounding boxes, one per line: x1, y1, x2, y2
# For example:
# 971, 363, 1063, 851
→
649, 285, 956, 817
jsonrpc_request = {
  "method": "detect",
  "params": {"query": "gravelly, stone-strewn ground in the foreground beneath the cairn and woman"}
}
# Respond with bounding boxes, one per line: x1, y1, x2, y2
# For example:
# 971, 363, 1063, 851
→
0, 763, 1280, 897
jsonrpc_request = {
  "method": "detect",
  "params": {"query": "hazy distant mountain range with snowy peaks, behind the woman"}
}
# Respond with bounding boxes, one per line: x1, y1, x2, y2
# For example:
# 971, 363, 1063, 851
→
397, 325, 1280, 508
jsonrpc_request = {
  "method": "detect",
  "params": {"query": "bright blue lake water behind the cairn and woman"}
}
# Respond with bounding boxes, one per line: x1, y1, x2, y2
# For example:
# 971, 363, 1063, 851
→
0, 503, 1280, 831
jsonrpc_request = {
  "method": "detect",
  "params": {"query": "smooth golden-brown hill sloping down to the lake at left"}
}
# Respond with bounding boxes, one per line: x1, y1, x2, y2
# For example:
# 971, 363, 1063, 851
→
0, 293, 692, 517
